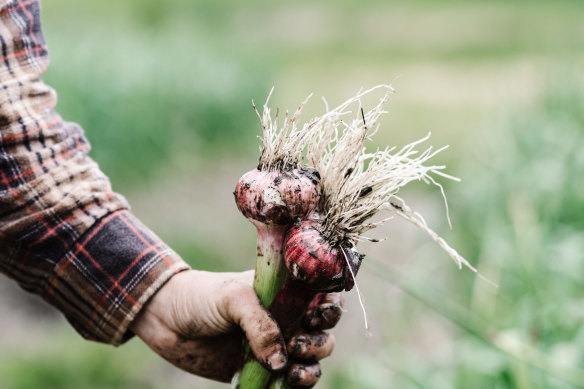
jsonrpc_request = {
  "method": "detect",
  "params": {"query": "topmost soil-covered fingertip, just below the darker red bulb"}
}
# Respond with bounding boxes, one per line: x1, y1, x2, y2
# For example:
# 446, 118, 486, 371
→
304, 293, 344, 330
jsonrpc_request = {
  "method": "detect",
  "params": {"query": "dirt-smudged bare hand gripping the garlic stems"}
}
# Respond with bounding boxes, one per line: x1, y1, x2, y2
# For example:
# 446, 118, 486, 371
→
131, 270, 342, 387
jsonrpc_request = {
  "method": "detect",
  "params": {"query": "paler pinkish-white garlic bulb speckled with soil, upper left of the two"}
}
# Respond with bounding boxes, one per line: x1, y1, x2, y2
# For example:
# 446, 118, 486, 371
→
233, 167, 322, 225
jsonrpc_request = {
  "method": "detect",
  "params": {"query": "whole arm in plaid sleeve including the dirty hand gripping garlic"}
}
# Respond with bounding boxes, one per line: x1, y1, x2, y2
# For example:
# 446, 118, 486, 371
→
0, 0, 340, 386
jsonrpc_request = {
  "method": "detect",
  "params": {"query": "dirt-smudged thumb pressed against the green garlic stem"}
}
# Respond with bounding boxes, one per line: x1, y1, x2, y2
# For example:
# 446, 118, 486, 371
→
227, 285, 288, 371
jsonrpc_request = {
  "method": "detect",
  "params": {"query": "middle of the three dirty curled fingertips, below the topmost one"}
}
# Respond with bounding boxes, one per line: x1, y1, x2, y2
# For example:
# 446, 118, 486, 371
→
287, 332, 335, 361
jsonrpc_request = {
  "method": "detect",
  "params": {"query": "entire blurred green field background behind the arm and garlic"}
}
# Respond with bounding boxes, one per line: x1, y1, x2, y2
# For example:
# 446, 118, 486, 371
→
0, 0, 584, 389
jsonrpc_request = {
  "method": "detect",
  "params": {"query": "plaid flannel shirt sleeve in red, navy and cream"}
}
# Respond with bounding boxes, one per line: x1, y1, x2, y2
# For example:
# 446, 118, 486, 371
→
0, 0, 188, 345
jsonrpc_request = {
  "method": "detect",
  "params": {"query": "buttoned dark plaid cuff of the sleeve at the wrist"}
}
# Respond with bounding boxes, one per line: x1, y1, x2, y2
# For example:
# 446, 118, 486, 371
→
44, 210, 189, 346
